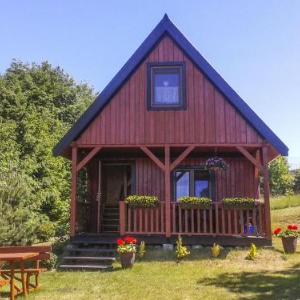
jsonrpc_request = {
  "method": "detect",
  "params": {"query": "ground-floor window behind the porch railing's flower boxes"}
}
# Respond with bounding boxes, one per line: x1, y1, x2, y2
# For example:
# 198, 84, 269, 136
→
174, 169, 214, 200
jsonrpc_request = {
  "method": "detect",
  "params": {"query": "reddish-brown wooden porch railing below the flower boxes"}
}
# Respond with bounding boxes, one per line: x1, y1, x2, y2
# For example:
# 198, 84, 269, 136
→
120, 201, 266, 237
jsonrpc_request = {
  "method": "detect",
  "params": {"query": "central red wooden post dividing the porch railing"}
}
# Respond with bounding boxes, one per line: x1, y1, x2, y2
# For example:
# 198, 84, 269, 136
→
165, 146, 171, 237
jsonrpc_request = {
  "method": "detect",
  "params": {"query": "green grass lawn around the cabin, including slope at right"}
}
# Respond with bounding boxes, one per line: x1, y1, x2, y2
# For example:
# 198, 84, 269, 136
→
6, 198, 300, 300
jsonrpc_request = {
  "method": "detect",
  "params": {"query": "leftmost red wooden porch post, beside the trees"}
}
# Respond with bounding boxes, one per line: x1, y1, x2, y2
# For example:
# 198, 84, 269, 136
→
70, 145, 77, 236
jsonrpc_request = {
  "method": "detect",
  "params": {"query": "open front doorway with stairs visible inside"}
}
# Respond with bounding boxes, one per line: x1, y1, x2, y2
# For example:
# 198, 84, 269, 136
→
101, 163, 133, 232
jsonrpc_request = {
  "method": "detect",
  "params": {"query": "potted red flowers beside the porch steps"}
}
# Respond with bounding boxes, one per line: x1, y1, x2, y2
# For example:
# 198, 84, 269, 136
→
117, 236, 136, 269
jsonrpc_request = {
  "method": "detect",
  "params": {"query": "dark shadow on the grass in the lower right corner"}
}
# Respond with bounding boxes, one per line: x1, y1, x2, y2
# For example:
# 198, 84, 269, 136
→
197, 263, 300, 300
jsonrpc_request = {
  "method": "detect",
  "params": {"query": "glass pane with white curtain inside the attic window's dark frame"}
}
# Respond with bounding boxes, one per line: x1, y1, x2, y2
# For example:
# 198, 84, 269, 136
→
154, 73, 179, 105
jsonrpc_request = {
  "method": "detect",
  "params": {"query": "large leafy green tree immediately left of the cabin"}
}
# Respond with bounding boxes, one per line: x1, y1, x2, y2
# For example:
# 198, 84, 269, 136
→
0, 61, 95, 235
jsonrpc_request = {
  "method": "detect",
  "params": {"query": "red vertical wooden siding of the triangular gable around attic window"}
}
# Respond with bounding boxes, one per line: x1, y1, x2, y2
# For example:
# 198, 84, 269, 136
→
77, 37, 262, 144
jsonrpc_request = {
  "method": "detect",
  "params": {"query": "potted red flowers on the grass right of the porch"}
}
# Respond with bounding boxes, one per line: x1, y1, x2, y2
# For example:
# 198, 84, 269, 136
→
273, 224, 300, 253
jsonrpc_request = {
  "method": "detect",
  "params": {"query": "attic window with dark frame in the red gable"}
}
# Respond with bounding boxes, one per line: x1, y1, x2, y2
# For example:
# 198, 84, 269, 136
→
148, 63, 185, 110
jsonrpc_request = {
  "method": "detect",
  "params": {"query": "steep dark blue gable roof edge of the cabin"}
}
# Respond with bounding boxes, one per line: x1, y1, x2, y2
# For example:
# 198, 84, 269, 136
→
53, 15, 288, 156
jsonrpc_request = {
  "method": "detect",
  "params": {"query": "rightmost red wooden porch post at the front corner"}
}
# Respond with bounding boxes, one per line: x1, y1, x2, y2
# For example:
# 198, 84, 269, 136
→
262, 145, 272, 240
